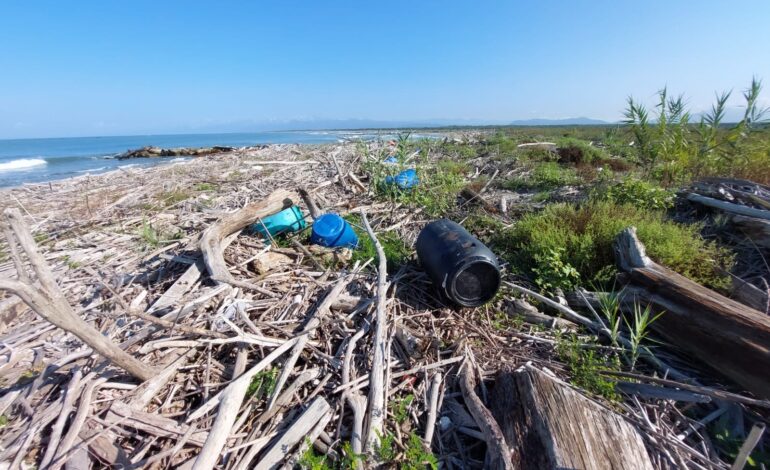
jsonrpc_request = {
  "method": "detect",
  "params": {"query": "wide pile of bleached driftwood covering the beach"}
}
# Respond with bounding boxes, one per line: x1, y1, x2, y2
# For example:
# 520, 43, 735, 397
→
0, 143, 770, 469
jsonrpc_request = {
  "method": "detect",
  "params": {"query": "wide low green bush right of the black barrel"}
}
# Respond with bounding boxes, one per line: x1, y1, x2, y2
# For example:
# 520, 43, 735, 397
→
492, 201, 733, 290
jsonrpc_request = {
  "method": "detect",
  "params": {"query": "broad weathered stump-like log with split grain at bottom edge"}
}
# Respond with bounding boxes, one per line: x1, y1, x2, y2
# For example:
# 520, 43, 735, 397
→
490, 365, 654, 470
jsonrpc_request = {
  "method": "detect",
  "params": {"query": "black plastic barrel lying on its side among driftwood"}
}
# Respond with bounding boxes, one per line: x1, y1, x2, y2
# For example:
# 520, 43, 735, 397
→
416, 219, 500, 307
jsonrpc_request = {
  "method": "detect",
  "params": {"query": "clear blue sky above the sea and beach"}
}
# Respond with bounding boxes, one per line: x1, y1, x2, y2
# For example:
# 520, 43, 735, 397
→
0, 0, 770, 138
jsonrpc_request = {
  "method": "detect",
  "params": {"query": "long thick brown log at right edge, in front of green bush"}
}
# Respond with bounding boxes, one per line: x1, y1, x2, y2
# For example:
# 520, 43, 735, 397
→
615, 227, 770, 398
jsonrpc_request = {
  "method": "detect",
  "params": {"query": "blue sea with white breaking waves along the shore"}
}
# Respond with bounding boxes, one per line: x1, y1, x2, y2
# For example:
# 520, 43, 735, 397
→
0, 129, 435, 187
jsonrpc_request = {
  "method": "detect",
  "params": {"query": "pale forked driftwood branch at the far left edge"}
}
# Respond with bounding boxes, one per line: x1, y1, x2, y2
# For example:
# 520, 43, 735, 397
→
0, 208, 156, 381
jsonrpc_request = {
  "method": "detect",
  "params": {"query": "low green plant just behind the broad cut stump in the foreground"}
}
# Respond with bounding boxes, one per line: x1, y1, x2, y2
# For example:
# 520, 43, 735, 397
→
556, 337, 620, 402
